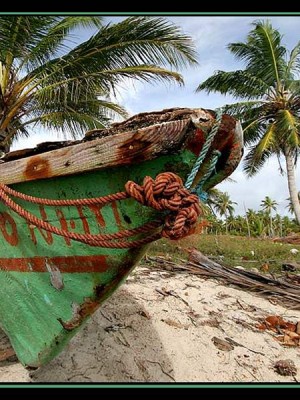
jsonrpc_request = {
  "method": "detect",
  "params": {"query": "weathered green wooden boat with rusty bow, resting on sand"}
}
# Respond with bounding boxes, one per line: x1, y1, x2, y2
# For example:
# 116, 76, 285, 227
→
0, 109, 242, 367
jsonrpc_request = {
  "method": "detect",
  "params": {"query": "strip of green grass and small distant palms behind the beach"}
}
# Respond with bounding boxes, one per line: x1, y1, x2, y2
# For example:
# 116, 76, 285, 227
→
149, 188, 300, 272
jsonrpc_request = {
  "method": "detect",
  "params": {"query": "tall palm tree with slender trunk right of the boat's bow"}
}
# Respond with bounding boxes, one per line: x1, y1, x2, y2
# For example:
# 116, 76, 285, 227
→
197, 21, 300, 224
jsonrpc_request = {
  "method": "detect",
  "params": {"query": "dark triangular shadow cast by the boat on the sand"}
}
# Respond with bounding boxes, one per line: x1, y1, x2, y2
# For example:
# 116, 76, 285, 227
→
30, 288, 174, 382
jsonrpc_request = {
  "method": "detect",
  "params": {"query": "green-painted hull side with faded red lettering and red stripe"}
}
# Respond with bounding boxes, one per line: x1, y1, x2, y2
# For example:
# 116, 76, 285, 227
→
0, 108, 241, 367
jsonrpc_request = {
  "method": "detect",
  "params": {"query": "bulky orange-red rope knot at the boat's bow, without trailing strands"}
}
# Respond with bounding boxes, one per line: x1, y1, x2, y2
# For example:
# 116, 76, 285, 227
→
125, 172, 201, 240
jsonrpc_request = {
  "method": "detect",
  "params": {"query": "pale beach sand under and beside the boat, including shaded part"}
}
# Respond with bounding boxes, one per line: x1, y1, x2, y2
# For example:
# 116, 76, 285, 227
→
0, 267, 300, 383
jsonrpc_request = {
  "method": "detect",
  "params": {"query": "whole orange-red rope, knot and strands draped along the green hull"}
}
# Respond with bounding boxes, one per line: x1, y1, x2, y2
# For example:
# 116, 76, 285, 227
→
0, 172, 201, 249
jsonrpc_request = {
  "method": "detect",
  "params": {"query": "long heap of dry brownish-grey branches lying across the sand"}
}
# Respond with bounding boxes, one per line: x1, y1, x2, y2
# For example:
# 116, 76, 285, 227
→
148, 250, 300, 310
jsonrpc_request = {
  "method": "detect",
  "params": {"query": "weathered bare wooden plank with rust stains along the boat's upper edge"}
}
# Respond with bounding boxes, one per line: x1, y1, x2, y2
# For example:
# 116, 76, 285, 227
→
0, 118, 191, 184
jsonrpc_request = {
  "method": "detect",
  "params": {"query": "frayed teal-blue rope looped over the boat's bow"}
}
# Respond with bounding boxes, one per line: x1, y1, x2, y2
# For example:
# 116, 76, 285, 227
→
185, 108, 223, 196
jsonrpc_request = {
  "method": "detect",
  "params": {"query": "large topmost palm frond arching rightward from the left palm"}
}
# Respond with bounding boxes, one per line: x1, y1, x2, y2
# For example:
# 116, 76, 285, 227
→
27, 17, 197, 87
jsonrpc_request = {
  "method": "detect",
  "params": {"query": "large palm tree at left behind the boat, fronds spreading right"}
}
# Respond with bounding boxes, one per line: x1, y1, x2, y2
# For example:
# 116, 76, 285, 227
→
0, 16, 196, 150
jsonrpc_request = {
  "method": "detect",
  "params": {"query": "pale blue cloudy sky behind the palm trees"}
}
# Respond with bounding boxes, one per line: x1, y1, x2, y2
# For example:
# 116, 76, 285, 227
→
14, 16, 300, 215
